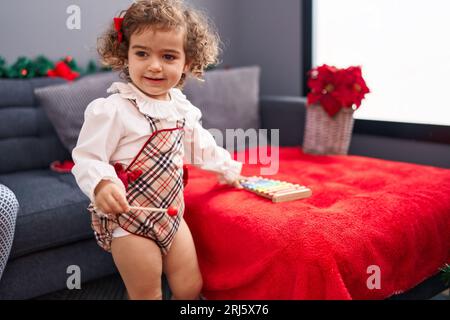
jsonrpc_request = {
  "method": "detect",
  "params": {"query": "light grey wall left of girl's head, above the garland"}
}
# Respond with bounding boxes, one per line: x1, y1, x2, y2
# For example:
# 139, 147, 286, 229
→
0, 0, 133, 67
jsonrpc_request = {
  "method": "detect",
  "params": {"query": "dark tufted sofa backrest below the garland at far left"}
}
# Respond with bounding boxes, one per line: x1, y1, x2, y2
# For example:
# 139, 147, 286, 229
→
0, 78, 69, 174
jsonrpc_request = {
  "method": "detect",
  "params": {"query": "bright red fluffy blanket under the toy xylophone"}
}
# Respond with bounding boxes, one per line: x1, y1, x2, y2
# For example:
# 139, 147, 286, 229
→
185, 148, 450, 299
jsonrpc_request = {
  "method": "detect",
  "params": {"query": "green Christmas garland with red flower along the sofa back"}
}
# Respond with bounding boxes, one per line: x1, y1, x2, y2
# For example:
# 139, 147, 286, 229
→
0, 55, 110, 81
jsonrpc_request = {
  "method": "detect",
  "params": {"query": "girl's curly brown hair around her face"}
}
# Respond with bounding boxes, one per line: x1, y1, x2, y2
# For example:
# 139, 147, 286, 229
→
97, 0, 220, 88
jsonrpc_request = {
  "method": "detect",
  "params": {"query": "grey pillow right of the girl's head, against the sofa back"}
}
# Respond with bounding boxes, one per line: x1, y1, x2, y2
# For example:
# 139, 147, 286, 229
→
183, 66, 260, 134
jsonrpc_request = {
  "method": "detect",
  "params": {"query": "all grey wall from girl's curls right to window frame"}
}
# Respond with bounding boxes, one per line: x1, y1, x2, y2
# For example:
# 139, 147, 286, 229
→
191, 0, 303, 96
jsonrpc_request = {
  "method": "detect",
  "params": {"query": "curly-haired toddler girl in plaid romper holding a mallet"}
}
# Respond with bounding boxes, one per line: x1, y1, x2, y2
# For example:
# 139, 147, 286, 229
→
72, 0, 242, 299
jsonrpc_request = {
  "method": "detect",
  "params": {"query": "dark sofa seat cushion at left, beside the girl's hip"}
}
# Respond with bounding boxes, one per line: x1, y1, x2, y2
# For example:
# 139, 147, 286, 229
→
0, 170, 93, 259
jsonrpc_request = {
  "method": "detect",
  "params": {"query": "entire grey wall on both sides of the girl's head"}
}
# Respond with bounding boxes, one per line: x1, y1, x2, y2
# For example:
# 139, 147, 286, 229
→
0, 0, 302, 95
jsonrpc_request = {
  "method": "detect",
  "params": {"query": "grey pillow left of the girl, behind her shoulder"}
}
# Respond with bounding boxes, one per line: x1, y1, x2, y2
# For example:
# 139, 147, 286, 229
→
35, 72, 120, 152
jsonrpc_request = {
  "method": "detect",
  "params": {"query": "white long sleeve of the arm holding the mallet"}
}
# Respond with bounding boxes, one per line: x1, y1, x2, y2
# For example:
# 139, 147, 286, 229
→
72, 98, 125, 202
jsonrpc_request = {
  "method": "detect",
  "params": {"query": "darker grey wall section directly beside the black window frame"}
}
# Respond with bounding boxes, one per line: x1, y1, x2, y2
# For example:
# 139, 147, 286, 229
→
234, 0, 303, 96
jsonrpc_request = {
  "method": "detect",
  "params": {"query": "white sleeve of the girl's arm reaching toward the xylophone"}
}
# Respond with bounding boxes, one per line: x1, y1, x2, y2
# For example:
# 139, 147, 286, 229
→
184, 108, 242, 183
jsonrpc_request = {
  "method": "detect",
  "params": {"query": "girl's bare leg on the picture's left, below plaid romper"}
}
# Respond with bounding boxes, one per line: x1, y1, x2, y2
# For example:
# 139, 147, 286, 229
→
111, 235, 162, 300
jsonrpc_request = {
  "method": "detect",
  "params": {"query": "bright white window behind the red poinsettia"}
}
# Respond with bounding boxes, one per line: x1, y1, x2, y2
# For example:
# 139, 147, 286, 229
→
312, 0, 450, 125
